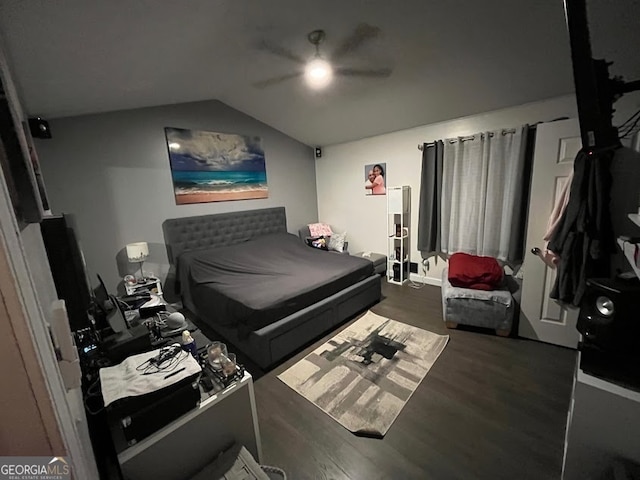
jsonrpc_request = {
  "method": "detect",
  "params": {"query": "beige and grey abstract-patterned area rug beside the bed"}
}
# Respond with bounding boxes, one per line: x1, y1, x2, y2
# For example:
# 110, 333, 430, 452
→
278, 312, 449, 437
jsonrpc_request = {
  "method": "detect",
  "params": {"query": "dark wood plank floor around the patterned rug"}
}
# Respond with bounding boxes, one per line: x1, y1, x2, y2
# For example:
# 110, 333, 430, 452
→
249, 282, 576, 480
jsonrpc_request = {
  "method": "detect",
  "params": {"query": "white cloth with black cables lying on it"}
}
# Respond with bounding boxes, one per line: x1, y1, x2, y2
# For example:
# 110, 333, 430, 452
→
100, 344, 202, 407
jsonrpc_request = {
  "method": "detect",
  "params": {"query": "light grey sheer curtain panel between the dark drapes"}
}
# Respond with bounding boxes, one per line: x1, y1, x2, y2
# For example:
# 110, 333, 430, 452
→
440, 126, 527, 260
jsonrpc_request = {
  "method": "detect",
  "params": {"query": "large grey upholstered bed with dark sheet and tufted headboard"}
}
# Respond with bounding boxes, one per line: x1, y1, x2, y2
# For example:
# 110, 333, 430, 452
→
163, 207, 381, 368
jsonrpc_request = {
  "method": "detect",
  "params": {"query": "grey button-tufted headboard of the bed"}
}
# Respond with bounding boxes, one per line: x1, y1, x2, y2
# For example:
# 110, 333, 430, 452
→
162, 207, 287, 265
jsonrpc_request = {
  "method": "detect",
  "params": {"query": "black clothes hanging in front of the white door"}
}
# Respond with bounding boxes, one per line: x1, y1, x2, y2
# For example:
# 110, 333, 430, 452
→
548, 149, 615, 306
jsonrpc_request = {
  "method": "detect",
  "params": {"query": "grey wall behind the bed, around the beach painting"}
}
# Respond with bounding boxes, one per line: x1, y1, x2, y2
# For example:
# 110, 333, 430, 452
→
37, 101, 317, 292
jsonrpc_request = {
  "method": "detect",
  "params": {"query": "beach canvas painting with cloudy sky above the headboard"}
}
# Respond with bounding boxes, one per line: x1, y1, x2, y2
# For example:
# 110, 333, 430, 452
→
165, 128, 269, 205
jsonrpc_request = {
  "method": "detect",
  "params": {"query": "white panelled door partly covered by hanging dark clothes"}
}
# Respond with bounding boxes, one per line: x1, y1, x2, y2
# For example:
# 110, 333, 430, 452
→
518, 119, 582, 348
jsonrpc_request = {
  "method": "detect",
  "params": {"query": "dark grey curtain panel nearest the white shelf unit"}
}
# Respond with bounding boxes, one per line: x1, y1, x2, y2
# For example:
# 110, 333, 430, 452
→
418, 140, 444, 258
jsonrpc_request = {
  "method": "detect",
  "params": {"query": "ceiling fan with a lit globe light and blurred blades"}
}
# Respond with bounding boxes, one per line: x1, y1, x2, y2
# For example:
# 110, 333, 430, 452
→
253, 23, 392, 88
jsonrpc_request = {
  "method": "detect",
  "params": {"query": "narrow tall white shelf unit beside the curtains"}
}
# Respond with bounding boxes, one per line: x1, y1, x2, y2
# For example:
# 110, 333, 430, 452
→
387, 185, 411, 285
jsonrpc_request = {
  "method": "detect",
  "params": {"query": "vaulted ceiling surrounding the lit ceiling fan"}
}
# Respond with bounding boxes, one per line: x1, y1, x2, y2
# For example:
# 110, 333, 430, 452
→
0, 0, 640, 145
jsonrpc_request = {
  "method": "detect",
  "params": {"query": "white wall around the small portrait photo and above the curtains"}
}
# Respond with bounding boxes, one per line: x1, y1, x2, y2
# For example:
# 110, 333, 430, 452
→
316, 95, 577, 285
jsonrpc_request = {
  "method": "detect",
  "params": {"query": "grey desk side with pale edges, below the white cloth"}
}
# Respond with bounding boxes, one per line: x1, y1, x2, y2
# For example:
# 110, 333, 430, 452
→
118, 372, 262, 480
